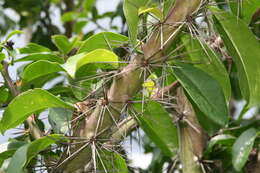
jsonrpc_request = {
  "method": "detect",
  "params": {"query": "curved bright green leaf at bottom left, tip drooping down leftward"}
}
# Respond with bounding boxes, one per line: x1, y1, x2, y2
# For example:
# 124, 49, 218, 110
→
23, 134, 65, 168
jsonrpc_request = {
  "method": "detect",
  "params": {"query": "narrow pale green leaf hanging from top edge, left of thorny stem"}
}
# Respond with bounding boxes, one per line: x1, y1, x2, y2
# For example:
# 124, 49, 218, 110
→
123, 0, 149, 46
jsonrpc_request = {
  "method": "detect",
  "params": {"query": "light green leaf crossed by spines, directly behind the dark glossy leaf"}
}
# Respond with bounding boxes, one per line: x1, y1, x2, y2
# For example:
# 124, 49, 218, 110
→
182, 35, 231, 102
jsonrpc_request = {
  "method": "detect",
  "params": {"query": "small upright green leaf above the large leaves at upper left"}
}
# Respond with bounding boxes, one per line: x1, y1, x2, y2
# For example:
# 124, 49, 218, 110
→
51, 35, 73, 55
